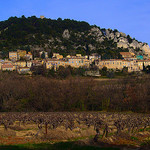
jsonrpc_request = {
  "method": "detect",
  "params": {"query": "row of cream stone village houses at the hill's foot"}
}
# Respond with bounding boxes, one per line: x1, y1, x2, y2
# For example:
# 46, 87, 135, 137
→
0, 50, 150, 74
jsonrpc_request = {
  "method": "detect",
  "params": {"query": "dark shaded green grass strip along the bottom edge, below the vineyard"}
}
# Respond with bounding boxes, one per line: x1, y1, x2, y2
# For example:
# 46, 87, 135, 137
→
0, 142, 119, 150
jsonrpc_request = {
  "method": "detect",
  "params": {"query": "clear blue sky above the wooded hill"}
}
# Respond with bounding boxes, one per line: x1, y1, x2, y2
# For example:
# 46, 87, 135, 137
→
0, 0, 150, 45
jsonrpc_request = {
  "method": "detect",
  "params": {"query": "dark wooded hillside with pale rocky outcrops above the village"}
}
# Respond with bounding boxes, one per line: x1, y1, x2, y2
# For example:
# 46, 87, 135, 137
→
0, 16, 150, 59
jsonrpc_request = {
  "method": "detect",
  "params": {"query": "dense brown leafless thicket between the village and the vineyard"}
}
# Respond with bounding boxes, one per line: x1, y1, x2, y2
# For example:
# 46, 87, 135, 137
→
0, 73, 150, 112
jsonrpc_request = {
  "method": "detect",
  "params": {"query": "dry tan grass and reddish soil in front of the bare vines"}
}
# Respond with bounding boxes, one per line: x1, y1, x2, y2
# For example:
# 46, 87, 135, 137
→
0, 123, 150, 150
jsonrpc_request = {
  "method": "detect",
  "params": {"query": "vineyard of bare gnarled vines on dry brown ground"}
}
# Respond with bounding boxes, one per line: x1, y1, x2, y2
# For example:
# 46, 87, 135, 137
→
0, 112, 150, 146
